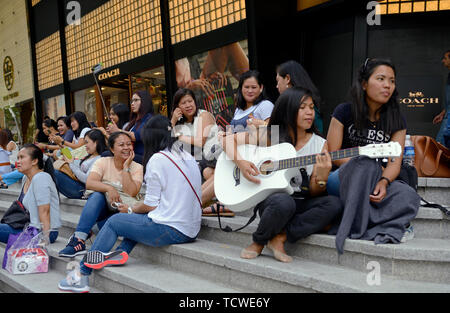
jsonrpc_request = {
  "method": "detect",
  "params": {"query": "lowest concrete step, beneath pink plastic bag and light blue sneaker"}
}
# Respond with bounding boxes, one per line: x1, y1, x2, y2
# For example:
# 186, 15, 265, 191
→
0, 237, 249, 294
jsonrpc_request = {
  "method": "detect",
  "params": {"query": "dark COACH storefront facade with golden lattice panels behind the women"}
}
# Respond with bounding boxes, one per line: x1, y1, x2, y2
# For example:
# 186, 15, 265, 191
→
27, 0, 450, 136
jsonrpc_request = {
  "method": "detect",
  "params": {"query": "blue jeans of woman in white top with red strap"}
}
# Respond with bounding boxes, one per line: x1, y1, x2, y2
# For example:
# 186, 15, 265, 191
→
80, 213, 195, 275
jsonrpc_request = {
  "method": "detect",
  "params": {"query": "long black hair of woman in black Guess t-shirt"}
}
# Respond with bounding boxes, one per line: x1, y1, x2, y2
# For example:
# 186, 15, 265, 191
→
350, 58, 406, 134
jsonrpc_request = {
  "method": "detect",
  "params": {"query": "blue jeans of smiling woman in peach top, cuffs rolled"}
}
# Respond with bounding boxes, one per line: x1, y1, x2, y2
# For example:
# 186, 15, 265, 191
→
75, 192, 114, 240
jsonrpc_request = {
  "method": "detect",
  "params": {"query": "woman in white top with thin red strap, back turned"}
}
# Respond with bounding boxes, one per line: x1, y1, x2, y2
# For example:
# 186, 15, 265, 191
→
58, 115, 201, 292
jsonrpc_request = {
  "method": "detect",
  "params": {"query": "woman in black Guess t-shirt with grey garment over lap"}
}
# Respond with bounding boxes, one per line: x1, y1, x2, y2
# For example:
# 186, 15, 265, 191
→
327, 59, 420, 253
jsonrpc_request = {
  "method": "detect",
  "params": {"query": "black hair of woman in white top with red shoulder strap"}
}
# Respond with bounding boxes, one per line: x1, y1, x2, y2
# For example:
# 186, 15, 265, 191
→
142, 115, 177, 174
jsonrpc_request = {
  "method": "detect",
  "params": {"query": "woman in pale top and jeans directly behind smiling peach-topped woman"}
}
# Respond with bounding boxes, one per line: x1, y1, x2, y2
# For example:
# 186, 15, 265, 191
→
55, 129, 108, 199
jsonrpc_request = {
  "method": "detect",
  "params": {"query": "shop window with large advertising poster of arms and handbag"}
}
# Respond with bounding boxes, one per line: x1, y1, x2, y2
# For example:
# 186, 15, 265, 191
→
175, 40, 249, 128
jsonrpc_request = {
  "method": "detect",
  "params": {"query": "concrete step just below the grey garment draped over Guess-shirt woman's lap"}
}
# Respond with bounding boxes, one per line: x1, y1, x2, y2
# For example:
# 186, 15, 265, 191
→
199, 216, 450, 284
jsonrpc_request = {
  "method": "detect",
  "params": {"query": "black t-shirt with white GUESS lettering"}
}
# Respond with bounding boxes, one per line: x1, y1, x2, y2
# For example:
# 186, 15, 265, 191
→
333, 102, 406, 149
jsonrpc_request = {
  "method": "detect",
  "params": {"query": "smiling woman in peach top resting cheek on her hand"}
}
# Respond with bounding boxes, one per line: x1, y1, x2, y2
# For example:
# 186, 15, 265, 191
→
59, 132, 143, 257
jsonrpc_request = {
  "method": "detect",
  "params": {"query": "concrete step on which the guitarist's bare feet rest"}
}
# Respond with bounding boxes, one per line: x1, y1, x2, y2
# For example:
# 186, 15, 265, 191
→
125, 239, 450, 292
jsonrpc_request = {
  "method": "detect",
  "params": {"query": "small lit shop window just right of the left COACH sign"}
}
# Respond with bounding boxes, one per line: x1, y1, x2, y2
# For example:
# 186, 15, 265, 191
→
130, 66, 167, 116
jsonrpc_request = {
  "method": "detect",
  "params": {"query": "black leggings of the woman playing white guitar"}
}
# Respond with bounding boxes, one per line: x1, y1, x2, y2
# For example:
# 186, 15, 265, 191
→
253, 193, 342, 245
